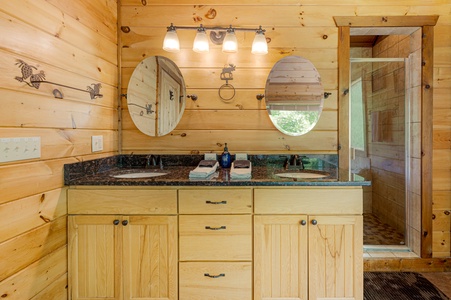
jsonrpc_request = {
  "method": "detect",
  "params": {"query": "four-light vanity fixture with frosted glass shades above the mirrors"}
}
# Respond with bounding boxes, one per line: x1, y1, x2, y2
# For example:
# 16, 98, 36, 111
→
163, 23, 268, 54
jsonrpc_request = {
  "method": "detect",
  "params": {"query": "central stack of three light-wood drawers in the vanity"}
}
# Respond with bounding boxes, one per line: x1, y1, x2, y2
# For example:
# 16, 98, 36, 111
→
179, 188, 252, 300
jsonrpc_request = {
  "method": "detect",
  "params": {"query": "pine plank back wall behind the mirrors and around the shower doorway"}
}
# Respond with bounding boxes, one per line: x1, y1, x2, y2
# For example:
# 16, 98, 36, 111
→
120, 0, 451, 257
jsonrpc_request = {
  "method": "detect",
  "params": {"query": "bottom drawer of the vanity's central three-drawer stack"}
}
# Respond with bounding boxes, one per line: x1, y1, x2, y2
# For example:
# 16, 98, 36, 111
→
179, 262, 252, 300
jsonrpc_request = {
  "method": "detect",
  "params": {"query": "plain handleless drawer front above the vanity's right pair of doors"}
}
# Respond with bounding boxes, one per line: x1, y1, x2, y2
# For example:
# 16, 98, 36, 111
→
254, 187, 363, 215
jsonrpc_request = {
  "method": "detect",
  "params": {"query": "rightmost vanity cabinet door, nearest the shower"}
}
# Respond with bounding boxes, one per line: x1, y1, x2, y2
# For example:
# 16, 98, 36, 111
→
308, 216, 363, 300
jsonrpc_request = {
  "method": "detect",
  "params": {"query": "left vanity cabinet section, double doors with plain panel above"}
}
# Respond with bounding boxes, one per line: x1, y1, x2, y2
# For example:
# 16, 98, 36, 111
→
68, 189, 178, 300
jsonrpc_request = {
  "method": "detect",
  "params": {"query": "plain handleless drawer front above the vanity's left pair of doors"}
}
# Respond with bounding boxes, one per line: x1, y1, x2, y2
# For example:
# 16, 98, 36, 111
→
67, 189, 177, 215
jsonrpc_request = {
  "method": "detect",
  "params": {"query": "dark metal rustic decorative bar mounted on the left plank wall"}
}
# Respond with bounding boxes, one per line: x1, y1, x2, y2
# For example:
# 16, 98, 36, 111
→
15, 59, 103, 99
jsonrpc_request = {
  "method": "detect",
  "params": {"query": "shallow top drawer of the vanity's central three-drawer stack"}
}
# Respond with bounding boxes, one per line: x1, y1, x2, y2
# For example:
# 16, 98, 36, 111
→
179, 189, 252, 214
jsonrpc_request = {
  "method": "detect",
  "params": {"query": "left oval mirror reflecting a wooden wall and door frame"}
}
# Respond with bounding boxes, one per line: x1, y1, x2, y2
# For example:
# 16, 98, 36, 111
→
127, 56, 185, 136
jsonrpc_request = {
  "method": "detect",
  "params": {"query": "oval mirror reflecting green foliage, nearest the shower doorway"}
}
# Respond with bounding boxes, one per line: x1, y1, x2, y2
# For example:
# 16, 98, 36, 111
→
265, 56, 324, 136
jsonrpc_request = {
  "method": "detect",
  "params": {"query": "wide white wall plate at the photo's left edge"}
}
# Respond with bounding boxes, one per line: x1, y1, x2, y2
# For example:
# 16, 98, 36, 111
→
0, 136, 41, 163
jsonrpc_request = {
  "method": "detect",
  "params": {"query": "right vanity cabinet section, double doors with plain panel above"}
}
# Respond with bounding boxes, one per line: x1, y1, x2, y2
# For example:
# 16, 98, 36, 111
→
254, 187, 363, 300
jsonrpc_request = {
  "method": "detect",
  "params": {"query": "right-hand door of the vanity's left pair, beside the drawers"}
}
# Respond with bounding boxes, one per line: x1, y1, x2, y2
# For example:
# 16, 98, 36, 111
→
122, 216, 177, 300
